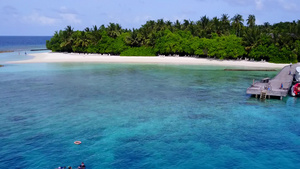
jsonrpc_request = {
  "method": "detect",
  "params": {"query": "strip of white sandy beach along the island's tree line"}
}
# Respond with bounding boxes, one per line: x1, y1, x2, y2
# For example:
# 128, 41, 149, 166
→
8, 52, 288, 69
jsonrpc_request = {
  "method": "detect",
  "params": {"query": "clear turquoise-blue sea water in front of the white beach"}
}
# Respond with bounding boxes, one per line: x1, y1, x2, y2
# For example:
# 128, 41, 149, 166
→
0, 36, 300, 169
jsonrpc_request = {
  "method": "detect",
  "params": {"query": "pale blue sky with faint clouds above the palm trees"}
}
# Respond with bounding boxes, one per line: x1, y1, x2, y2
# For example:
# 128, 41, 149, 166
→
0, 0, 300, 36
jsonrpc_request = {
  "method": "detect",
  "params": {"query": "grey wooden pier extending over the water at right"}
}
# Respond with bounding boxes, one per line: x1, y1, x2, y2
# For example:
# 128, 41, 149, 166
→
246, 64, 300, 99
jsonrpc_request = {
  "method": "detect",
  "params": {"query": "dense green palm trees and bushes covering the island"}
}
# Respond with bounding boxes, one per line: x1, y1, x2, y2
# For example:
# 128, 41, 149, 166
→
46, 14, 300, 63
